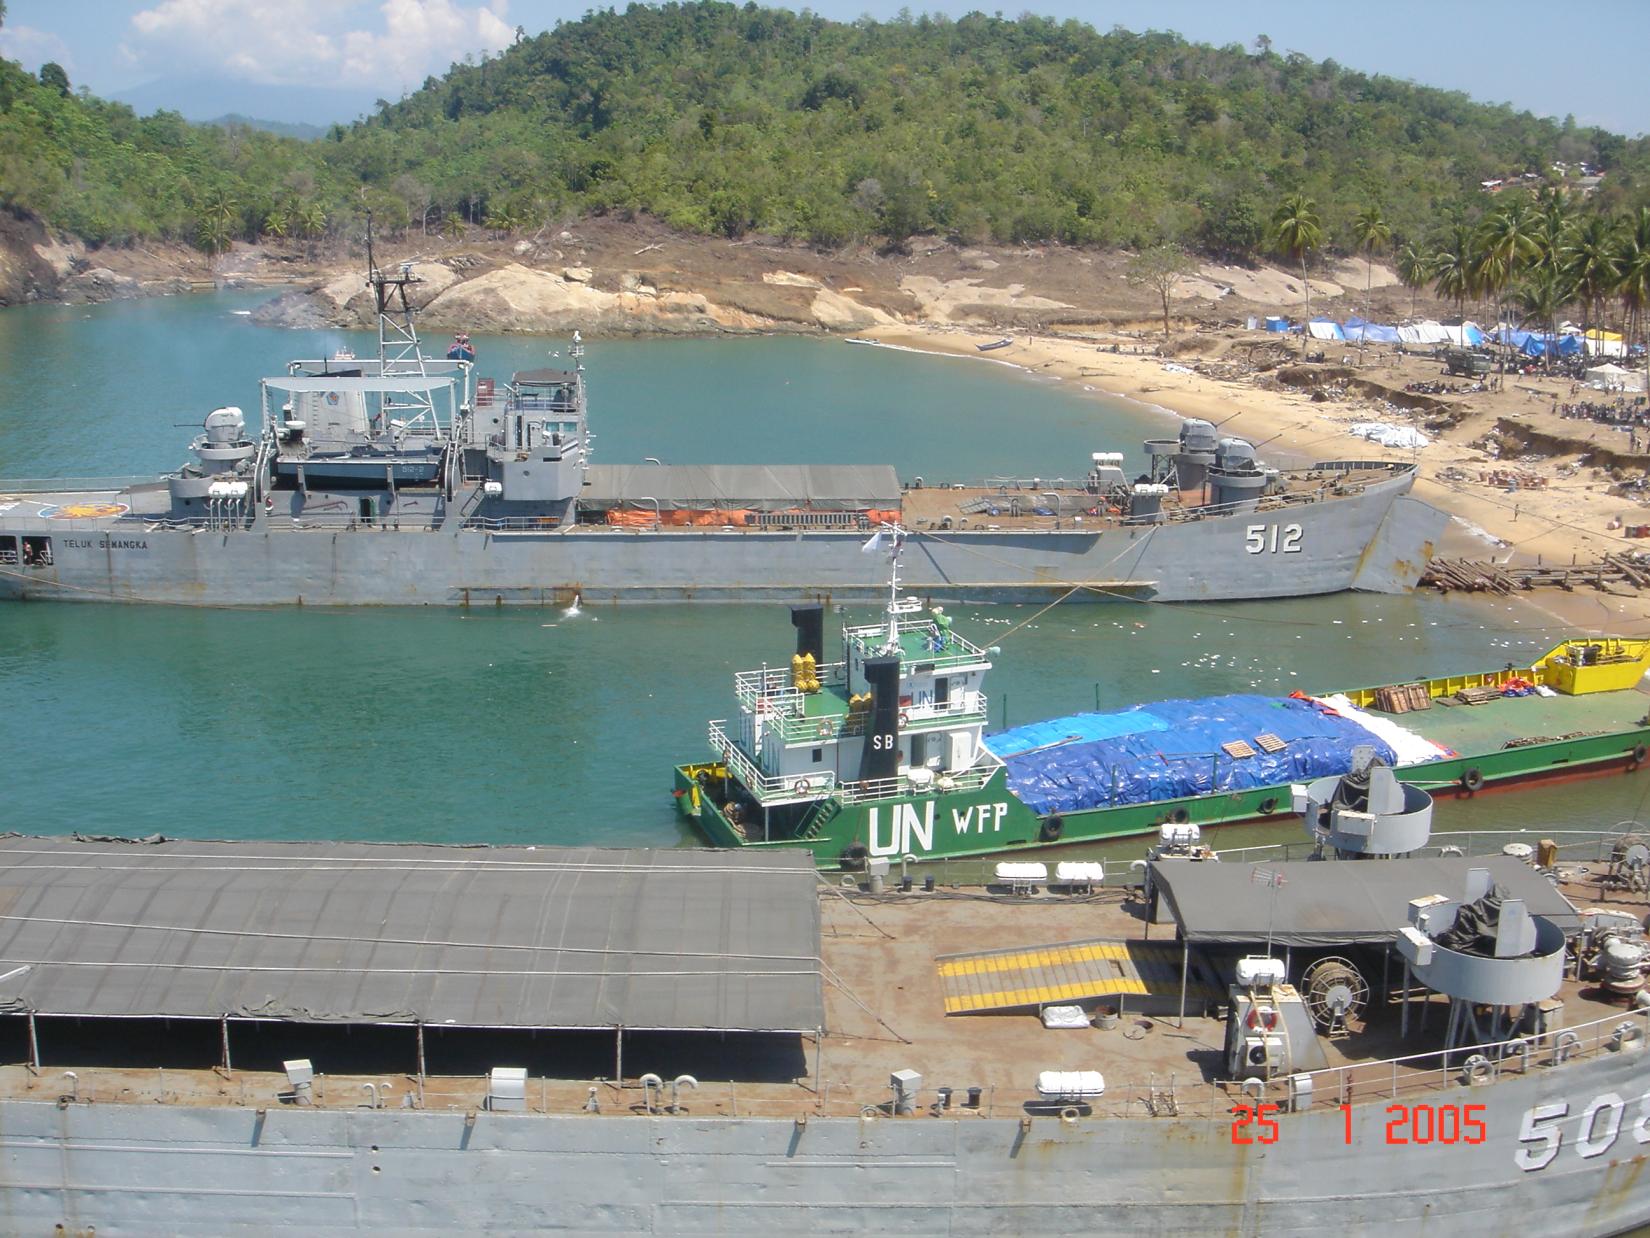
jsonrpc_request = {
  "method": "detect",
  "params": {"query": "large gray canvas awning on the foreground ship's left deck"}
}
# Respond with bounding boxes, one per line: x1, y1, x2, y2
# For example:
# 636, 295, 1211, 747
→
0, 835, 825, 1032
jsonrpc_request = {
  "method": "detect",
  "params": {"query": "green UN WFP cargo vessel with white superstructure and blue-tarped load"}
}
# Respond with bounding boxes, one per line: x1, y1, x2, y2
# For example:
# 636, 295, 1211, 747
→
673, 527, 1650, 868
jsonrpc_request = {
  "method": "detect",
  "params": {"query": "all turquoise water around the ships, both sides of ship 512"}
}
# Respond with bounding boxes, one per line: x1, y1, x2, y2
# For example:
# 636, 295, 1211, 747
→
0, 294, 1650, 845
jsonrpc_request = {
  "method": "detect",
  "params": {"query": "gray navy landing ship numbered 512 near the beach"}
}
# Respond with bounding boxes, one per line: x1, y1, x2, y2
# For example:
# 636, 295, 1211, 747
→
0, 266, 1445, 606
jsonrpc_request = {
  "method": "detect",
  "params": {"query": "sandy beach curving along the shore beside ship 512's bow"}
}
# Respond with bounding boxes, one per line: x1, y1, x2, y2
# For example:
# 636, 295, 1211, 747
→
863, 324, 1650, 634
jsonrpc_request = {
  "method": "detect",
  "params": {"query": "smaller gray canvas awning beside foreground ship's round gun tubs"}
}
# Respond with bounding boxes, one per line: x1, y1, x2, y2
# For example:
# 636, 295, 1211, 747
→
1153, 855, 1581, 946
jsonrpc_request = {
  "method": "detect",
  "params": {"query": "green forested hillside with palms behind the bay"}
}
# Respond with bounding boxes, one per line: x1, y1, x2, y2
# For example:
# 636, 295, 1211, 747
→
0, 0, 1650, 335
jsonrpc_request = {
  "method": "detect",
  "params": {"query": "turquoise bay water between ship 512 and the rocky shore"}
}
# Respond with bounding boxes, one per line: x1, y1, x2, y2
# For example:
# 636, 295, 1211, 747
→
0, 292, 1175, 480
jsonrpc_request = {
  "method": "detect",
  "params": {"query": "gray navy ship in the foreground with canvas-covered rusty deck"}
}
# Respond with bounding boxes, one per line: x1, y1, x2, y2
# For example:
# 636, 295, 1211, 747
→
0, 789, 1650, 1238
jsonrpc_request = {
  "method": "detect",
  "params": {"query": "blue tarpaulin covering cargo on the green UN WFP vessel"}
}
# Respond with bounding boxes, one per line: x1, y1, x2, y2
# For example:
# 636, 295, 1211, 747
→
985, 693, 1398, 814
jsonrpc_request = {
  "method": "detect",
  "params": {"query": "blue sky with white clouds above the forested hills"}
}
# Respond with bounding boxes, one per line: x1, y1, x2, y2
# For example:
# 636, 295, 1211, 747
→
0, 0, 1650, 134
